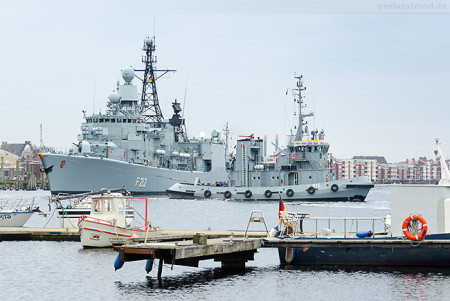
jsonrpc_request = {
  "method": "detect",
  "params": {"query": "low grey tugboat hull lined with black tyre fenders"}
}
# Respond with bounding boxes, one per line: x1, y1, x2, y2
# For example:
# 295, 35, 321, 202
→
167, 177, 374, 201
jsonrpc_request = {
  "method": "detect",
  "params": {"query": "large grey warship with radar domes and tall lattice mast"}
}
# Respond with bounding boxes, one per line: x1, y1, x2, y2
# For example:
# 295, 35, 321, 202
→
40, 38, 228, 194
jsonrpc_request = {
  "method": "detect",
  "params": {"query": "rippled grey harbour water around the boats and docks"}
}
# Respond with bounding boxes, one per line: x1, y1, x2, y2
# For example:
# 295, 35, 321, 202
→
0, 188, 450, 300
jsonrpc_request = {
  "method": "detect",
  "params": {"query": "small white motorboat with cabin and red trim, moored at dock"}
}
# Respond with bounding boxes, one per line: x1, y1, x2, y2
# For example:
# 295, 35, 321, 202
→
78, 193, 160, 248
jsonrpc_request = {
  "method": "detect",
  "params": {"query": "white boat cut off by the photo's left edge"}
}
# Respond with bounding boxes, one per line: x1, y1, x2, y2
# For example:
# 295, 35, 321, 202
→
0, 199, 41, 227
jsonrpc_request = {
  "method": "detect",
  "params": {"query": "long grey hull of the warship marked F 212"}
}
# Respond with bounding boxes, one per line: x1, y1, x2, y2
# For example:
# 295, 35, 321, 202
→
41, 154, 227, 195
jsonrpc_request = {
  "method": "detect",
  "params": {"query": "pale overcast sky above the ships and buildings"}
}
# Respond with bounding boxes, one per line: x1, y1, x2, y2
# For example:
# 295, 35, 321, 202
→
0, 0, 450, 162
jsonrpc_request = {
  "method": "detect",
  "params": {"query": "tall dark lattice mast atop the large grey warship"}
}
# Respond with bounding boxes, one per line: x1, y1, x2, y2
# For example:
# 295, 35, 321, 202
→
136, 37, 176, 123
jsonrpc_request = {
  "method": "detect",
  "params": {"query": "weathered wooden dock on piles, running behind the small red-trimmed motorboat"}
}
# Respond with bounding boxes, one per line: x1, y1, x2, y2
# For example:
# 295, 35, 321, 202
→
0, 227, 267, 279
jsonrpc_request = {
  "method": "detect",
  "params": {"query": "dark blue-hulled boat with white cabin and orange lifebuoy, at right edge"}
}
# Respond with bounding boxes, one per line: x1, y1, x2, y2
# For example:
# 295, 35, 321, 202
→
264, 140, 450, 267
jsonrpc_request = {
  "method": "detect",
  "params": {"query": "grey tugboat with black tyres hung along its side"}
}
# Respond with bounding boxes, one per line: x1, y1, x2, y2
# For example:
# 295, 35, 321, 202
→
167, 76, 373, 201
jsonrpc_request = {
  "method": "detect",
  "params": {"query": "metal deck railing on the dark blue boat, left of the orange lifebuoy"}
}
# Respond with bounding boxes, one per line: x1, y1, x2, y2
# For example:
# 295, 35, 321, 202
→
279, 212, 392, 238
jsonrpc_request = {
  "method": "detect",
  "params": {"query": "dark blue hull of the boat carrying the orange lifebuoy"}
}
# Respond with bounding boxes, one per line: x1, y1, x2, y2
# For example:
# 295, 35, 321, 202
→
278, 234, 450, 266
